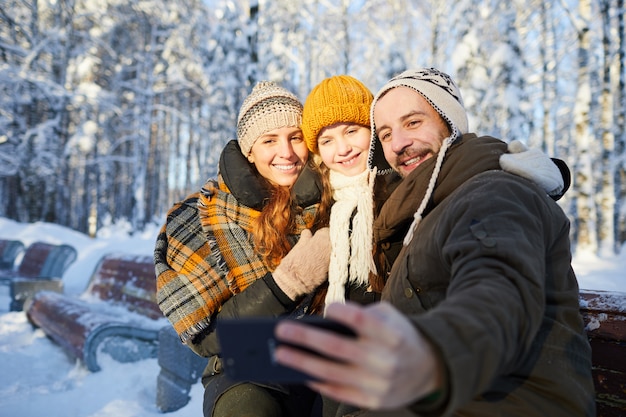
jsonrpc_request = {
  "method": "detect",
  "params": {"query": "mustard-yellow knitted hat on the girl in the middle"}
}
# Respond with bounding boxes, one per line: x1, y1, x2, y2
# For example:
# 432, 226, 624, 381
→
302, 75, 373, 153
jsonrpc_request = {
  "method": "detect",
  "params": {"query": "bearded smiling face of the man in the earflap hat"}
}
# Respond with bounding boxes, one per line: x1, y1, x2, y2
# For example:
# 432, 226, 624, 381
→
374, 87, 450, 178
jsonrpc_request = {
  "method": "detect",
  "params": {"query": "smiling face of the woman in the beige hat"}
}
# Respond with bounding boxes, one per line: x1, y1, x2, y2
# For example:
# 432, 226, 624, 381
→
248, 127, 309, 187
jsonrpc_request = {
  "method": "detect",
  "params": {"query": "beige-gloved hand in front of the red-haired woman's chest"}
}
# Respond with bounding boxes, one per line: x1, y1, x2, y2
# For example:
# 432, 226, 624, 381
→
272, 227, 330, 300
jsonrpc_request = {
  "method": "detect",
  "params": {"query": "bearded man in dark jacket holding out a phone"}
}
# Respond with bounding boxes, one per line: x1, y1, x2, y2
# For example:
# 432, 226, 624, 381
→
276, 69, 595, 417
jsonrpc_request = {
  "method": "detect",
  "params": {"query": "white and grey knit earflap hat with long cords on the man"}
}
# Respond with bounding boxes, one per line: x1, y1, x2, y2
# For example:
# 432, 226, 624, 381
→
369, 68, 468, 245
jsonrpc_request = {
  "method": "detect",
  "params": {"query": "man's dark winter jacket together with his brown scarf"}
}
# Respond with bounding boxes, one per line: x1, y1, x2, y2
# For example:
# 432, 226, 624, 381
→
364, 134, 595, 417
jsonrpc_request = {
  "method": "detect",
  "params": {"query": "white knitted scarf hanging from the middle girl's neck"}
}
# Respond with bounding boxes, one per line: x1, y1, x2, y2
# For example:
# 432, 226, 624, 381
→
325, 169, 376, 305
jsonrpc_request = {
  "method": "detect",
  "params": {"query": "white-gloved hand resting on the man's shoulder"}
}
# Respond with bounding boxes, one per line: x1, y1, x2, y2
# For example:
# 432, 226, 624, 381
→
500, 140, 564, 195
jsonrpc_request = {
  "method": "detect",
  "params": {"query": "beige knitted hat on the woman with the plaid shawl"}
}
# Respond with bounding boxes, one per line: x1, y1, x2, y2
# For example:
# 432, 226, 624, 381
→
237, 81, 302, 157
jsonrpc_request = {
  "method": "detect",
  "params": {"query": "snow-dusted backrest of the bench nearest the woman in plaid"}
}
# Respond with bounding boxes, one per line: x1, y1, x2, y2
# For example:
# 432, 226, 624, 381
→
85, 254, 163, 319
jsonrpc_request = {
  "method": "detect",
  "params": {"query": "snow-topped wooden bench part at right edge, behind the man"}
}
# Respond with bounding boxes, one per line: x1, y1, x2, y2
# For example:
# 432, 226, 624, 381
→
580, 290, 626, 417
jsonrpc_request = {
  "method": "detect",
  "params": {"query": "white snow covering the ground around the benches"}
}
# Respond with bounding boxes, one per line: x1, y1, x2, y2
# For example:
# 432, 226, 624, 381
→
0, 214, 626, 417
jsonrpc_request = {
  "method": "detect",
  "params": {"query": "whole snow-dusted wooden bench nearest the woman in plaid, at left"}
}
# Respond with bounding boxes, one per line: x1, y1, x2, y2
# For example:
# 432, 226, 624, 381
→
24, 254, 166, 372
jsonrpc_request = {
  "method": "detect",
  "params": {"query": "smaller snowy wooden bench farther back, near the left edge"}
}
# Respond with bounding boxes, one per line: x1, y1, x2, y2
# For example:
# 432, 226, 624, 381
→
0, 242, 77, 311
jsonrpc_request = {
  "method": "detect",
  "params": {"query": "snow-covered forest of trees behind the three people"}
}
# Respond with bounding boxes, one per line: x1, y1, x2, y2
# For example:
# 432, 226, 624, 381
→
0, 0, 626, 254
